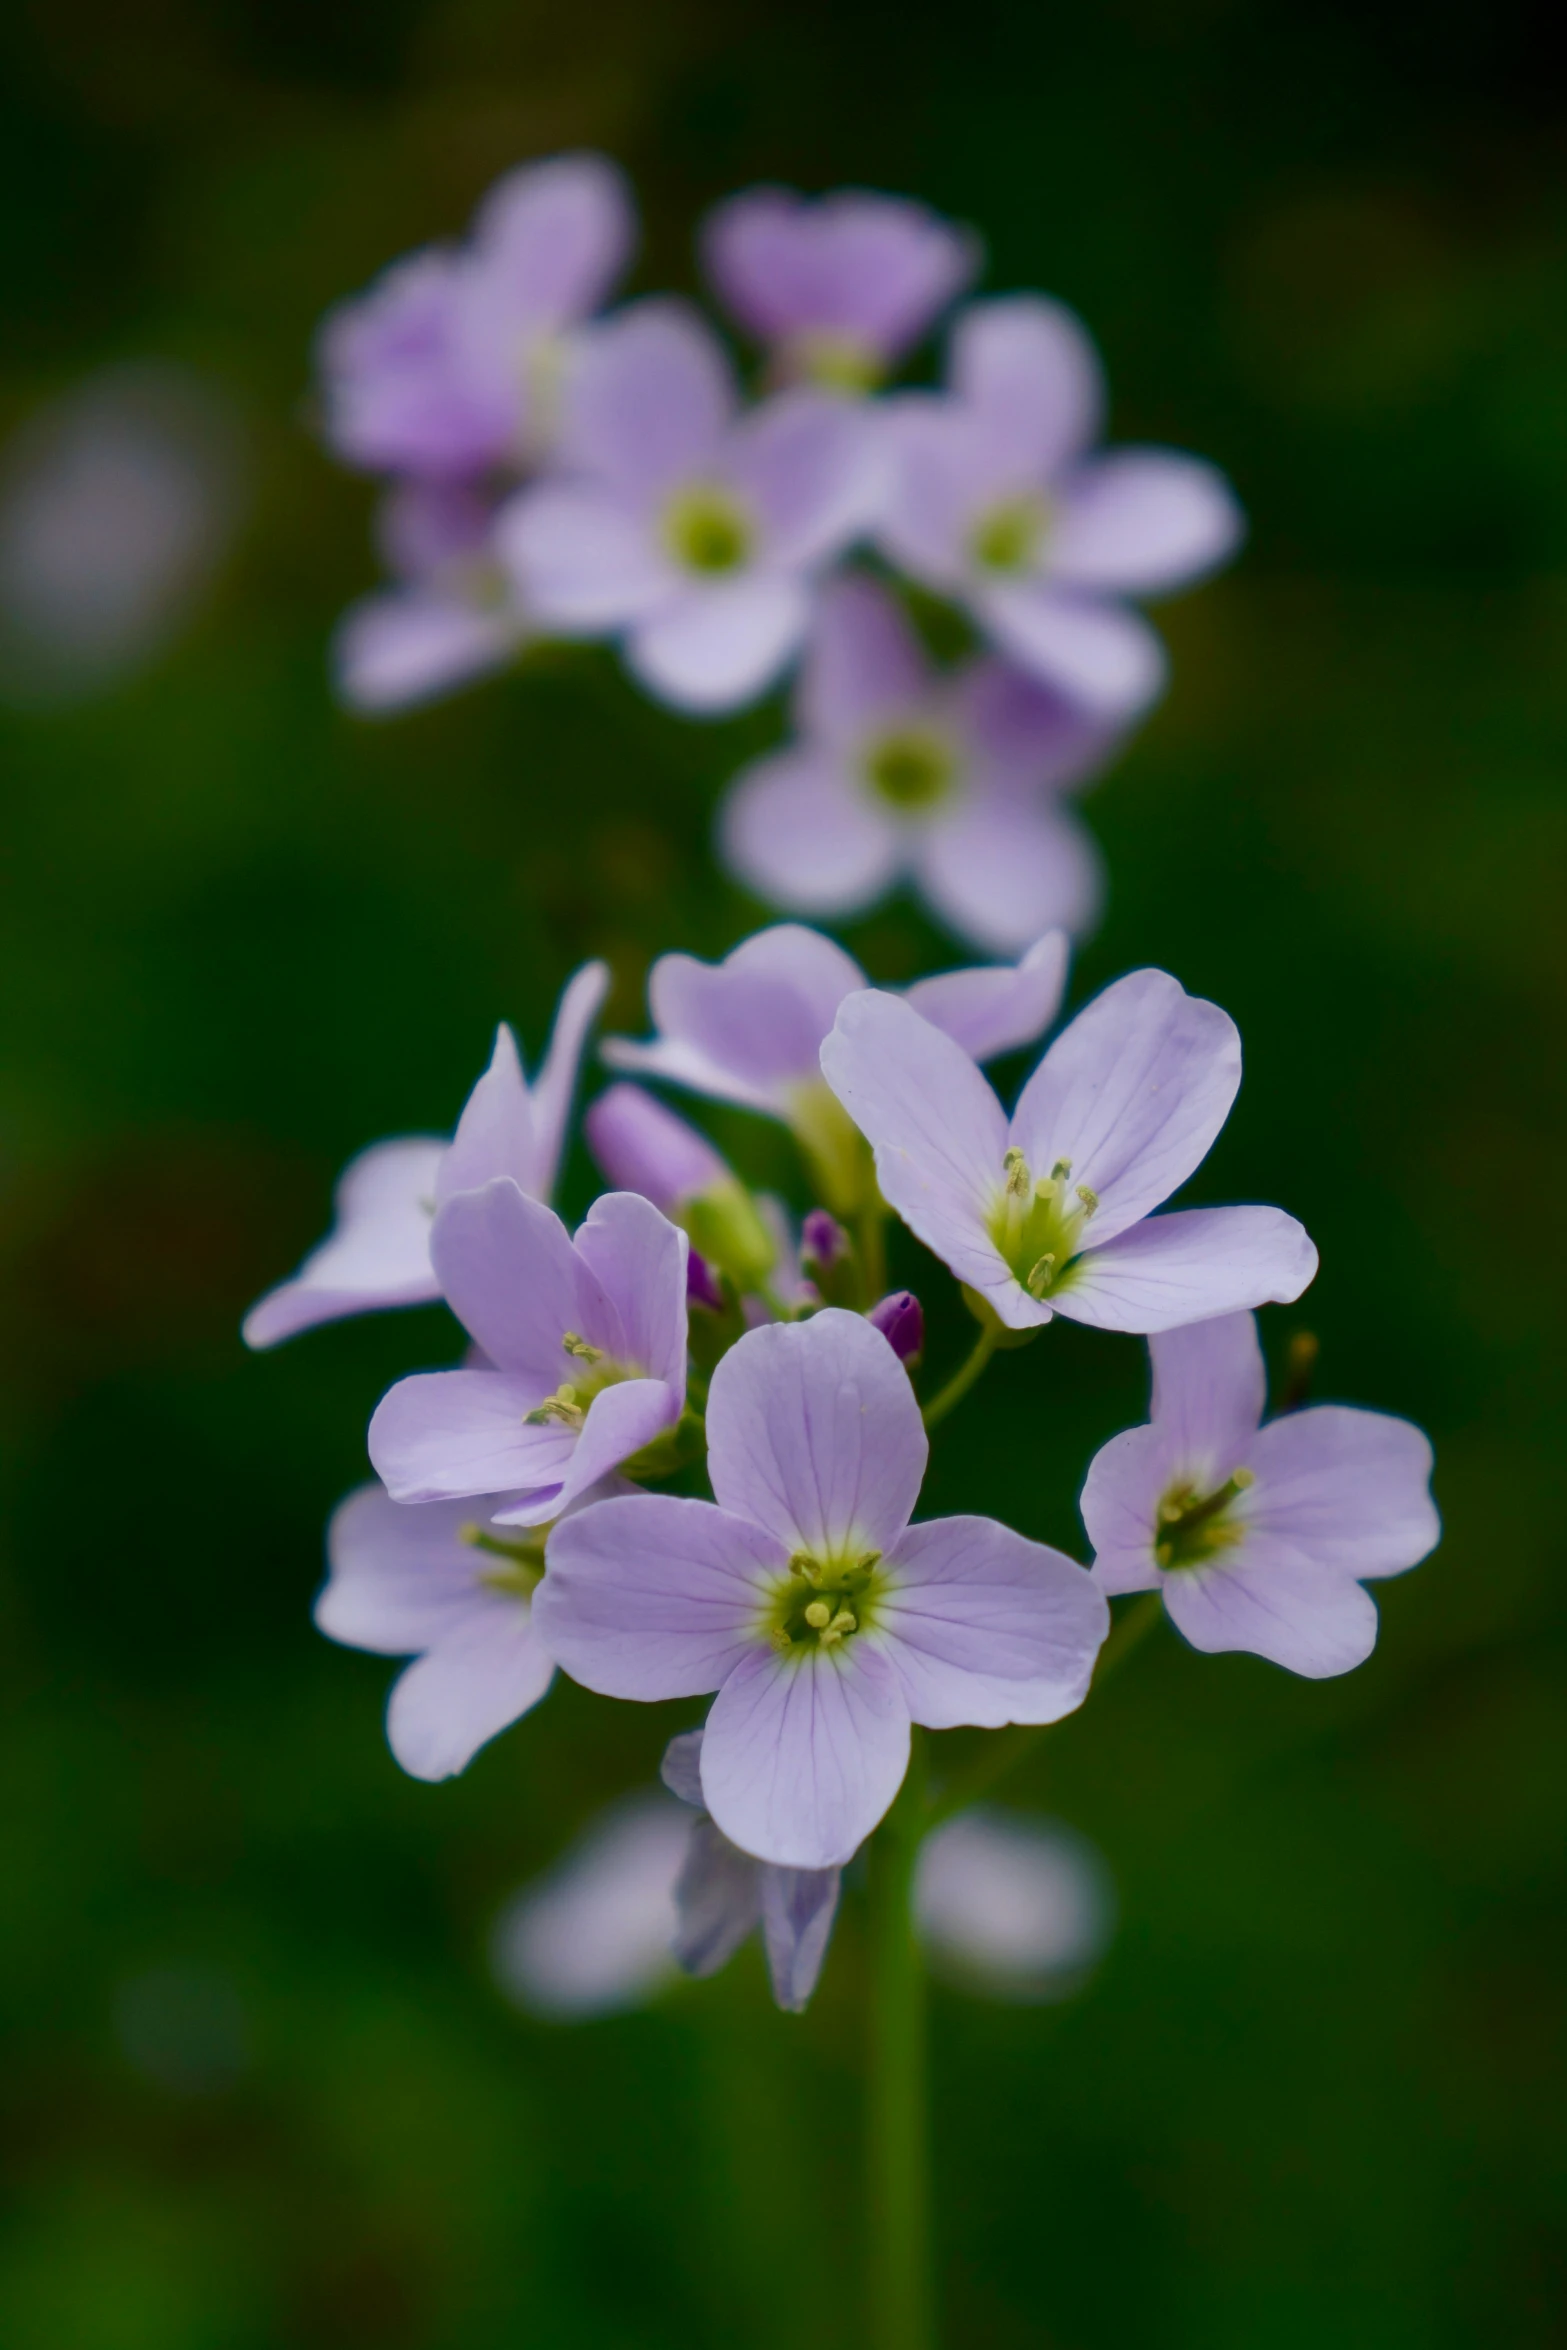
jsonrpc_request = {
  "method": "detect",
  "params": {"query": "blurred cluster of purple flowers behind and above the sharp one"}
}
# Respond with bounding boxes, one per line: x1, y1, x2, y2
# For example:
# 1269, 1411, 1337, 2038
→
320, 155, 1240, 954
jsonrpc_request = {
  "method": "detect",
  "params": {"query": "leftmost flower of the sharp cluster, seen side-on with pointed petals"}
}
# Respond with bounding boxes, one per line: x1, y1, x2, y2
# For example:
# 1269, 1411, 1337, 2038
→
244, 964, 608, 1347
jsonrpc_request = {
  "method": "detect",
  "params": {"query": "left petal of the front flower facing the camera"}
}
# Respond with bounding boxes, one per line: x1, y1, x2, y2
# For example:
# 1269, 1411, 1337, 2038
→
533, 1492, 787, 1699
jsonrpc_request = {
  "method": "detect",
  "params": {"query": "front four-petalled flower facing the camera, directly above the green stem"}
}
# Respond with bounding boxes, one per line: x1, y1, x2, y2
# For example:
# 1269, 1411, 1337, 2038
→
533, 1307, 1109, 1868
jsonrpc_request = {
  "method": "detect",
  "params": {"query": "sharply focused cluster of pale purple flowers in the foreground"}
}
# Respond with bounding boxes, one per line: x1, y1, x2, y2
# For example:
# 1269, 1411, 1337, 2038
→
247, 926, 1438, 2007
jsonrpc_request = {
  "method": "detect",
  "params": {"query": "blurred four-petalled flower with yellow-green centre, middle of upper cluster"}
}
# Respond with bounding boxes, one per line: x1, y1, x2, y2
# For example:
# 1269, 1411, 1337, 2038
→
496, 303, 879, 712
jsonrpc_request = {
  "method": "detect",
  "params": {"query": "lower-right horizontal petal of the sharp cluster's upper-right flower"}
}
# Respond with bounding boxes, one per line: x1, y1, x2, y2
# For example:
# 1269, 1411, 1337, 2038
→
1050, 1208, 1316, 1332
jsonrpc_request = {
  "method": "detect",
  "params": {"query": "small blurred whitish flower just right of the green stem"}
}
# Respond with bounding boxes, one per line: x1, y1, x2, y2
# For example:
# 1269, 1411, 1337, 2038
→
914, 1805, 1116, 2000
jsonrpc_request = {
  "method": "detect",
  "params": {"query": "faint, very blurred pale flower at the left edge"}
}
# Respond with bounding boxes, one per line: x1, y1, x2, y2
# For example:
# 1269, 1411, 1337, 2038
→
0, 362, 242, 703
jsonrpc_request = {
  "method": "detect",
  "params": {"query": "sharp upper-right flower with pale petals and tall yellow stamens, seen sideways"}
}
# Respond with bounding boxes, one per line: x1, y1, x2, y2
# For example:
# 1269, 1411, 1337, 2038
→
822, 971, 1316, 1330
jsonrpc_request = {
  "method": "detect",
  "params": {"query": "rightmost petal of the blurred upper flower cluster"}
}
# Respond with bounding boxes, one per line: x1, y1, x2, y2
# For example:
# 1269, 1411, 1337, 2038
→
1050, 449, 1245, 595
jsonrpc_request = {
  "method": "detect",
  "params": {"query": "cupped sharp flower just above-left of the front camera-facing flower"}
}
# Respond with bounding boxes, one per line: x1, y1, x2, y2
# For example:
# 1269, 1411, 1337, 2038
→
369, 1193, 686, 1525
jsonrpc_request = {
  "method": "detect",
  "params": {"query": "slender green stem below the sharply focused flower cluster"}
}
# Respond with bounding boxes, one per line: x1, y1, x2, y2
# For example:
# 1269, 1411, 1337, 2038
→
865, 1730, 935, 2350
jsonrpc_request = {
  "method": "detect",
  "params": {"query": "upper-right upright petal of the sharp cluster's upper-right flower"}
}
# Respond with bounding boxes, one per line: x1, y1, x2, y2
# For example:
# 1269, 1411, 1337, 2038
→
1013, 971, 1240, 1246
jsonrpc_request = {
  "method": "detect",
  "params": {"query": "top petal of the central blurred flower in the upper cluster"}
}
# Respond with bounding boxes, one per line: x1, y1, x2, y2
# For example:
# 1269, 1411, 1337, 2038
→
557, 301, 735, 503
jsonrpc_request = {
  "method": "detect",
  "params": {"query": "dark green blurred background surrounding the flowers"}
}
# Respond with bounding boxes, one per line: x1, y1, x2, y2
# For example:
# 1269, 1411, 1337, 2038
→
0, 0, 1567, 2350
